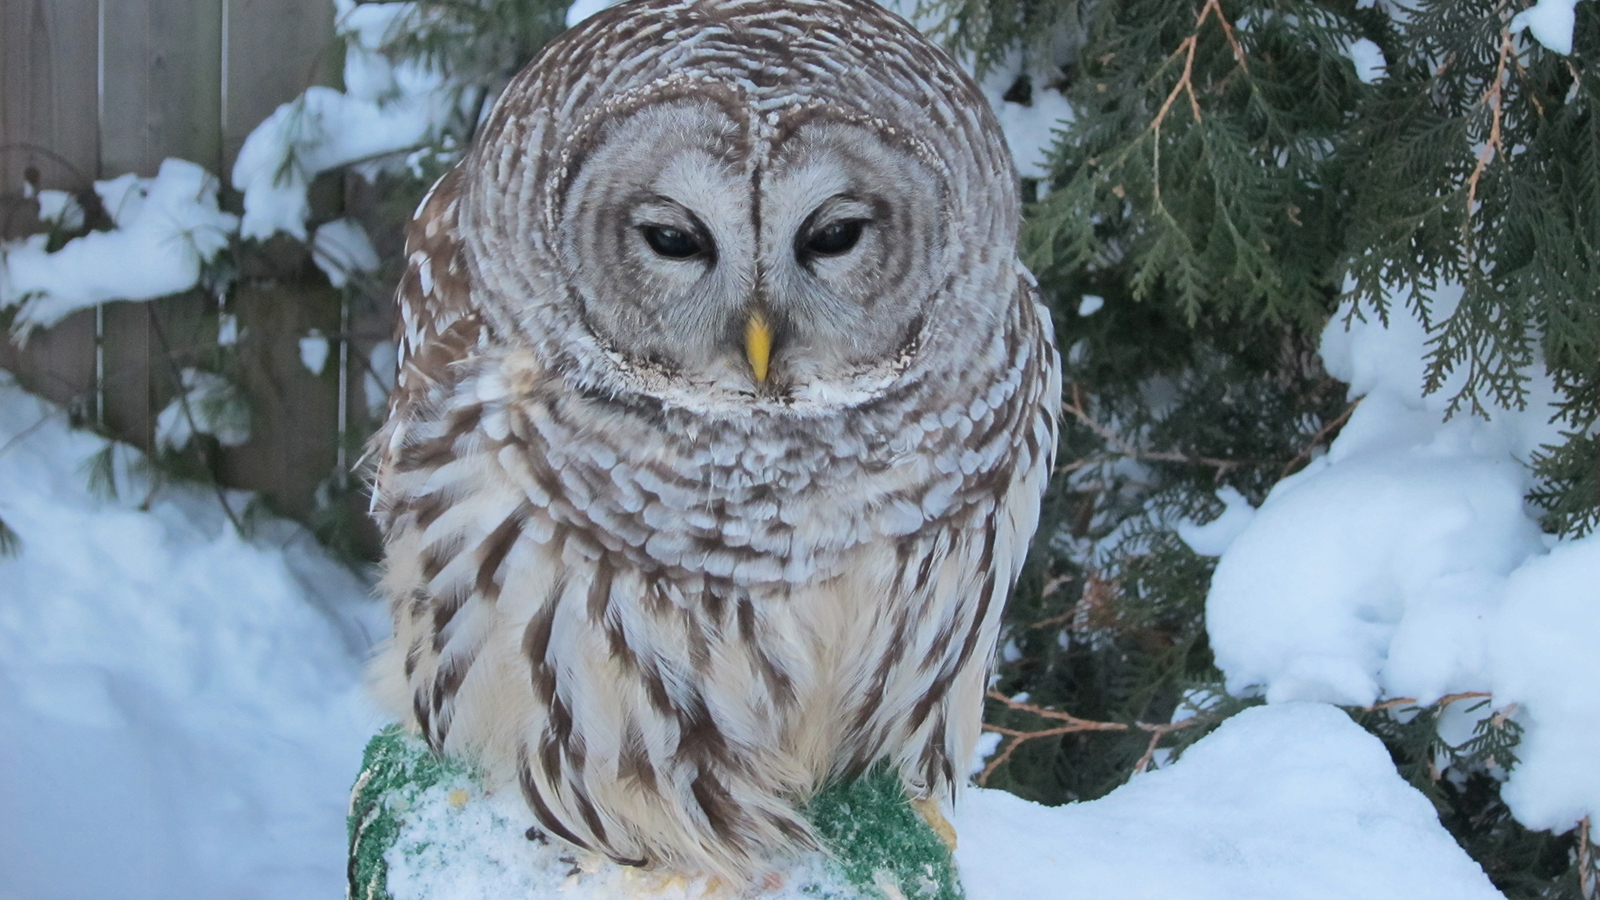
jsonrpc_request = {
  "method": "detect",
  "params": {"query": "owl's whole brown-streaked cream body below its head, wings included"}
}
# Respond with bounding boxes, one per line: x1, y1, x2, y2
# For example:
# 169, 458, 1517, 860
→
374, 178, 1059, 876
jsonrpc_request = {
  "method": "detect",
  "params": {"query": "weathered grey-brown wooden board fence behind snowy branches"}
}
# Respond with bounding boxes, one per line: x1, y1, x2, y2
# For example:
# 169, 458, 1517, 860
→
0, 0, 396, 538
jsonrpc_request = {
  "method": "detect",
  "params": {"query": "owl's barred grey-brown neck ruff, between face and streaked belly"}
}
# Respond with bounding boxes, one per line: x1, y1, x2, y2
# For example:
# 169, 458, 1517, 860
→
445, 275, 1046, 588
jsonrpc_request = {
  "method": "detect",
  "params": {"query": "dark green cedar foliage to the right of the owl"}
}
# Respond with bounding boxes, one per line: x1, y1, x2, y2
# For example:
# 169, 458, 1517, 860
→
920, 0, 1600, 898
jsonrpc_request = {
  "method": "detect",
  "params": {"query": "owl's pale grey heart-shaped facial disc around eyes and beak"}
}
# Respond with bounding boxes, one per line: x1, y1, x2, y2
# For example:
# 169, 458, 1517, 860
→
560, 101, 946, 404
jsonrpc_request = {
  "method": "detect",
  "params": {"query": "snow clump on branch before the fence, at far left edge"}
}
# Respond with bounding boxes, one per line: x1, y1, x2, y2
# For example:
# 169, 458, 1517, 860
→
0, 159, 238, 333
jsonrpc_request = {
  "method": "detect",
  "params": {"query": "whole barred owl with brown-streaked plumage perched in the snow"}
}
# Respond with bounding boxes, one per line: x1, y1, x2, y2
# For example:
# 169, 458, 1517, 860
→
374, 0, 1061, 878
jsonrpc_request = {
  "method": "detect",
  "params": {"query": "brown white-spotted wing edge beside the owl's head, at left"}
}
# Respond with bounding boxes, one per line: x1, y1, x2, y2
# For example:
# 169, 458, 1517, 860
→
371, 165, 486, 532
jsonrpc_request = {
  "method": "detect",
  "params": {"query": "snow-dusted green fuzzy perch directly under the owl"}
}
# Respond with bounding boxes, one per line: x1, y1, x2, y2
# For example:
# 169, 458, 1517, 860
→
349, 727, 962, 900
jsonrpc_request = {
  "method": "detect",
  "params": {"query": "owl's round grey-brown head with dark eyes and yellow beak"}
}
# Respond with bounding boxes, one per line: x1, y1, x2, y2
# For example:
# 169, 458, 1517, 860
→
462, 0, 1019, 415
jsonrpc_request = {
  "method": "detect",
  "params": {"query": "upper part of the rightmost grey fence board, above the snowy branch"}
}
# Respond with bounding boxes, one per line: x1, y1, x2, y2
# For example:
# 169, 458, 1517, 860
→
222, 0, 341, 181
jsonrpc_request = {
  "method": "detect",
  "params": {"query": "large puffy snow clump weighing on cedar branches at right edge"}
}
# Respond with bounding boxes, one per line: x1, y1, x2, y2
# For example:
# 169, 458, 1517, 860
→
1206, 285, 1600, 831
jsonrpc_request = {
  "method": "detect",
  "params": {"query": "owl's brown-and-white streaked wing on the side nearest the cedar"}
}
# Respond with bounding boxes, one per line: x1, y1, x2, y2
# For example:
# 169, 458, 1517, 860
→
843, 264, 1061, 796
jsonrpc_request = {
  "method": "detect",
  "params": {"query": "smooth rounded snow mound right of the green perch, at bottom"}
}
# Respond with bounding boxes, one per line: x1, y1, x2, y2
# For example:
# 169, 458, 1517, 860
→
955, 703, 1501, 900
